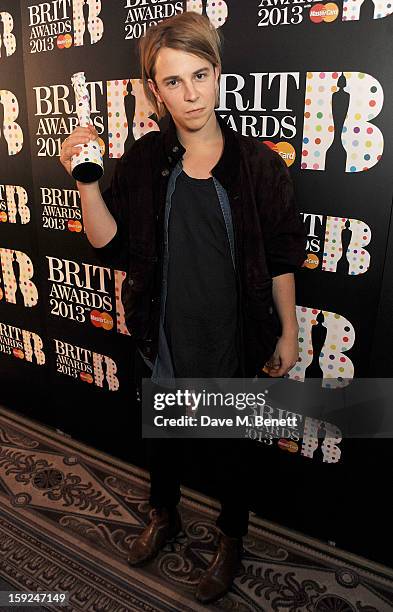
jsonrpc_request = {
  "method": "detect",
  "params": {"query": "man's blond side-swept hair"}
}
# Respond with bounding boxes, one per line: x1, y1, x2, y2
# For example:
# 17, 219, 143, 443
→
139, 11, 223, 119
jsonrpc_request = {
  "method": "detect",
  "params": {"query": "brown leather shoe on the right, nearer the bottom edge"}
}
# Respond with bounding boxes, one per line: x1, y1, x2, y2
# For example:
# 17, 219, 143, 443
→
195, 533, 243, 604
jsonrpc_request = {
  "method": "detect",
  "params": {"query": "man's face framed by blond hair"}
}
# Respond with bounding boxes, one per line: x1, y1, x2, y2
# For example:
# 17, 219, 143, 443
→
149, 47, 219, 130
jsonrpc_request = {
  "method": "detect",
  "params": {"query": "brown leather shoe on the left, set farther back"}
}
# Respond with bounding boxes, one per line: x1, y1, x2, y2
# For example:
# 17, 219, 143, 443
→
127, 508, 182, 567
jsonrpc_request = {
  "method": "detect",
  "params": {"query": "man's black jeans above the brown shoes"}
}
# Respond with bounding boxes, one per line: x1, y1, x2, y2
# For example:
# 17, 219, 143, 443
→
136, 354, 251, 537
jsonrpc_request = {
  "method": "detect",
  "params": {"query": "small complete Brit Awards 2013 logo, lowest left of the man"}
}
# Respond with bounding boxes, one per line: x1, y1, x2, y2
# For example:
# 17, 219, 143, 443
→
53, 338, 119, 391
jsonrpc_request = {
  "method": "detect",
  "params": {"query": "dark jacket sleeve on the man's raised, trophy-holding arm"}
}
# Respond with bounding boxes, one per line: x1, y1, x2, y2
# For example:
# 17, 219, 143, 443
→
91, 155, 132, 270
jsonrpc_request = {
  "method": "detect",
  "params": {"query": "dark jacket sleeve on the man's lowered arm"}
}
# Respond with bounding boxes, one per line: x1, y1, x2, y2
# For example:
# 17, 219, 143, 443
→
260, 145, 307, 277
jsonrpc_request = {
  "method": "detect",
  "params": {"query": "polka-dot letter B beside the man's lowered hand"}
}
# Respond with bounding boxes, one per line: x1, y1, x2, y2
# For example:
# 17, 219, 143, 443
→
288, 306, 355, 389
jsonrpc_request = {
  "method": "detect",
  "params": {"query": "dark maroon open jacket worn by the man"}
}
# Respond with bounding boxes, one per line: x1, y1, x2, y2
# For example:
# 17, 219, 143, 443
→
93, 111, 306, 376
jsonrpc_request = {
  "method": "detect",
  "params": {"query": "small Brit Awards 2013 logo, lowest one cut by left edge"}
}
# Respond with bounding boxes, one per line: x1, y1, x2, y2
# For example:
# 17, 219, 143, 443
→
0, 322, 46, 365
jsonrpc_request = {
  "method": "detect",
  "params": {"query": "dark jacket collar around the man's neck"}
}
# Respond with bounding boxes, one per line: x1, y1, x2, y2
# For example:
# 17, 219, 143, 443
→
164, 110, 240, 190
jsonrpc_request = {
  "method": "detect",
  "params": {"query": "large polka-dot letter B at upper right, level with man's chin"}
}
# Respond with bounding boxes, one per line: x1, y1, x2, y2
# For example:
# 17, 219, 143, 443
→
301, 72, 383, 172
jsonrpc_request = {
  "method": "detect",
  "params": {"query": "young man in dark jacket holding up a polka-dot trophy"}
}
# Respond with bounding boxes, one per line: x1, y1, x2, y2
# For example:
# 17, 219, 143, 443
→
60, 12, 306, 603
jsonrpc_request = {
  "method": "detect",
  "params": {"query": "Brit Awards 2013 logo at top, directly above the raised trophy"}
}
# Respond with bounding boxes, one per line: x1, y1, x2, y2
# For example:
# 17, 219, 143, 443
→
26, 0, 104, 53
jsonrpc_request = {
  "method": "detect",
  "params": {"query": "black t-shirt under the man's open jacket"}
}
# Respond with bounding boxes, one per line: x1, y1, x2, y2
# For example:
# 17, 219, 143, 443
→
164, 171, 239, 378
